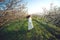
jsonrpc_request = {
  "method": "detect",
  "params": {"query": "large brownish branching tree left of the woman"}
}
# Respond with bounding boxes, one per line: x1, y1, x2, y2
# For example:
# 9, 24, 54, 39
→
0, 0, 26, 26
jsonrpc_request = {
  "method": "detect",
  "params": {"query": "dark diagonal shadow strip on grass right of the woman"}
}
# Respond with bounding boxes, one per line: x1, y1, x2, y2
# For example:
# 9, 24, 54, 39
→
34, 19, 60, 39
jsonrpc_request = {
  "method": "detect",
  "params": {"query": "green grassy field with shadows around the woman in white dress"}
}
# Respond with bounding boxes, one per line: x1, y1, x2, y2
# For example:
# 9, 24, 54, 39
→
0, 17, 60, 40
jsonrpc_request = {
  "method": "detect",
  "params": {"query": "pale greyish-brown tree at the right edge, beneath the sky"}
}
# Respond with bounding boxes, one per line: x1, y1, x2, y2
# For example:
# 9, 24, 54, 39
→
45, 3, 60, 26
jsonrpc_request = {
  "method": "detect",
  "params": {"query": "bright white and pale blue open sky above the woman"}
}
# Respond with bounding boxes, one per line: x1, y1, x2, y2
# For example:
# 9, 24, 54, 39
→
27, 0, 60, 14
